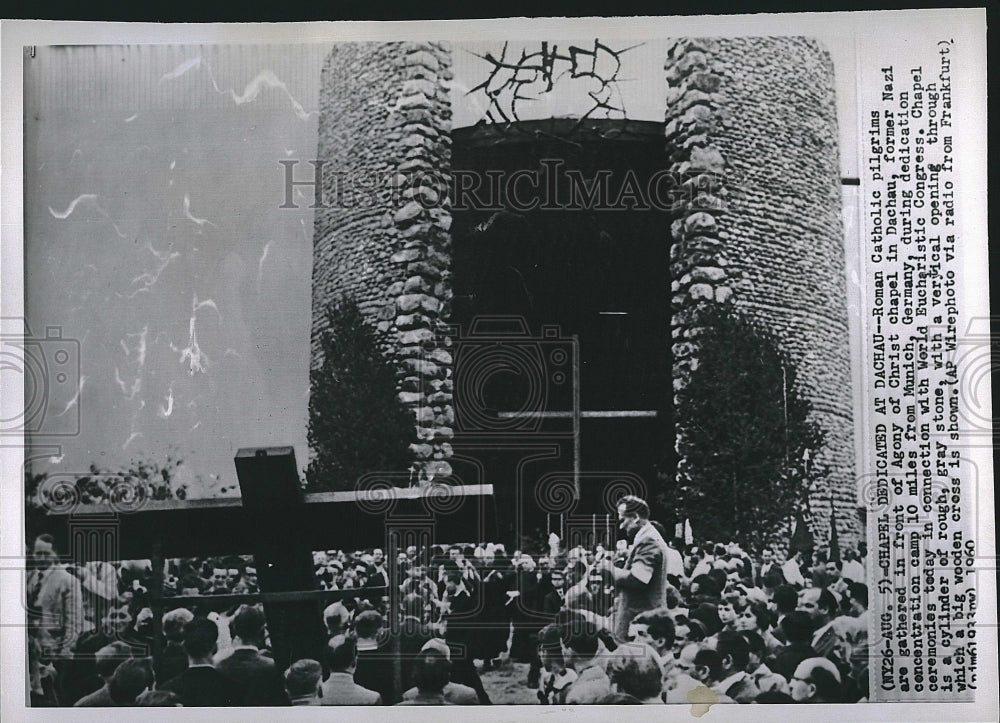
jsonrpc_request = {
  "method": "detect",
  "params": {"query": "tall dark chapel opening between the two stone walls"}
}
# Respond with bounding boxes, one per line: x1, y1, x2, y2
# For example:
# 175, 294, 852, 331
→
450, 120, 673, 544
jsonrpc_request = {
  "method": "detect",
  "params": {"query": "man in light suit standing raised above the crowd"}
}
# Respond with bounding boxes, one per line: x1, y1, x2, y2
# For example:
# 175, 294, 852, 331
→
607, 495, 667, 642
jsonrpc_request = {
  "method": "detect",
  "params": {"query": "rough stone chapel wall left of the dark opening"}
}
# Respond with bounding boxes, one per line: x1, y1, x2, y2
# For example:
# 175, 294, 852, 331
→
314, 43, 453, 475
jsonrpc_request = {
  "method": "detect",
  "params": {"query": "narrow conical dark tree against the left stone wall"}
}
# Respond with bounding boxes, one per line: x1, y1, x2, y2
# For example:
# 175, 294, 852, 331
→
306, 300, 414, 491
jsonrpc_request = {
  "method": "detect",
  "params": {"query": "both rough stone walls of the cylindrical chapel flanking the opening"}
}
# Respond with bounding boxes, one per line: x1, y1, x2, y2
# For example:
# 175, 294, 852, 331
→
313, 37, 863, 540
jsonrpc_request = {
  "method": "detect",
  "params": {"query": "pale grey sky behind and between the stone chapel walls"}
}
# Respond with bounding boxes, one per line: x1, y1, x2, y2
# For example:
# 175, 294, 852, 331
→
24, 38, 857, 494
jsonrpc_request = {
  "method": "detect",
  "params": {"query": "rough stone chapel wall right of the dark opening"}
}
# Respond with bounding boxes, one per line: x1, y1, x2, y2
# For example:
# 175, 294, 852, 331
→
665, 37, 862, 540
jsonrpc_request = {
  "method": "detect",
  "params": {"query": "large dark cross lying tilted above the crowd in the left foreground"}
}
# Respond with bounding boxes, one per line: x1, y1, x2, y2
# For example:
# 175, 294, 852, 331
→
45, 447, 495, 683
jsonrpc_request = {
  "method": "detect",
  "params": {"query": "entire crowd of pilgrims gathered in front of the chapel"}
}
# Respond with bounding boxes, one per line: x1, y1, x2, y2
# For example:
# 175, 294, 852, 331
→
28, 497, 868, 707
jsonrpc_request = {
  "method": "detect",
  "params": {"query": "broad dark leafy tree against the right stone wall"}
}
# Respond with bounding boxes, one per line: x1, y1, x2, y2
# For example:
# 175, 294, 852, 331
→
661, 307, 823, 549
